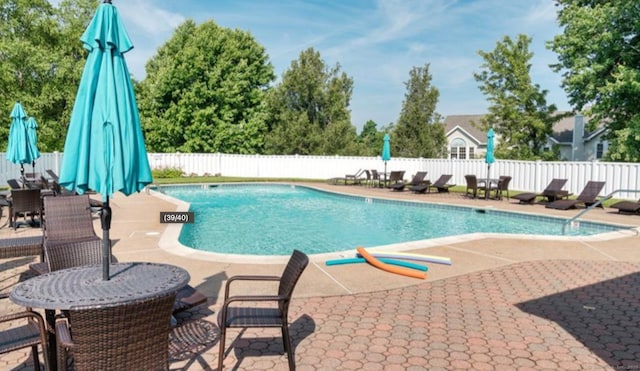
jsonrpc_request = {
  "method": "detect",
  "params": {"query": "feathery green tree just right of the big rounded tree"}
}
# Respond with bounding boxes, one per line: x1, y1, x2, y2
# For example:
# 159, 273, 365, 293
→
266, 48, 360, 155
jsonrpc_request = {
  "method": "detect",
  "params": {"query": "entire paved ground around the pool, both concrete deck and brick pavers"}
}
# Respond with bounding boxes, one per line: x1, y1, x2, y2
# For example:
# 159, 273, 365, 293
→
0, 183, 640, 370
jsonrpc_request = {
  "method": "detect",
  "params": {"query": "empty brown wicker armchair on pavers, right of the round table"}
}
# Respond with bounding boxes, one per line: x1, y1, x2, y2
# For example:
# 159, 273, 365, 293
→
218, 250, 309, 370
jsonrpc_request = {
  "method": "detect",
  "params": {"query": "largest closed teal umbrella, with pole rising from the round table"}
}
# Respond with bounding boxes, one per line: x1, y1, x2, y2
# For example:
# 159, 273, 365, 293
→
60, 1, 152, 280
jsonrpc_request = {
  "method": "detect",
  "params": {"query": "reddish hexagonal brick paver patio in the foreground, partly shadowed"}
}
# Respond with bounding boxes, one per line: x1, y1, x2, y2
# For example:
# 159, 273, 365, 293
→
165, 260, 640, 370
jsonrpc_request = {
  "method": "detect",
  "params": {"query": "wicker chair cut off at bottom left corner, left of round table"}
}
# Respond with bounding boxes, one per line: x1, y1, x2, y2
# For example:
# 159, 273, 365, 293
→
0, 294, 51, 371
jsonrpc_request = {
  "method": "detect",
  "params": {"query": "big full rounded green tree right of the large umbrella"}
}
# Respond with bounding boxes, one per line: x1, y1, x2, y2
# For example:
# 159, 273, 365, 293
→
139, 20, 275, 154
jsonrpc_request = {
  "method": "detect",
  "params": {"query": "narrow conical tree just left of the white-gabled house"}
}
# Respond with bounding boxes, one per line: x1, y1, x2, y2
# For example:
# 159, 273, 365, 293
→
391, 64, 447, 158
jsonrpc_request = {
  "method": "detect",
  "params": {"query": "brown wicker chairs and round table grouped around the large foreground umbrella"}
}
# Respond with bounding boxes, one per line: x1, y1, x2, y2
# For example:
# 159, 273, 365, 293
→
0, 190, 308, 370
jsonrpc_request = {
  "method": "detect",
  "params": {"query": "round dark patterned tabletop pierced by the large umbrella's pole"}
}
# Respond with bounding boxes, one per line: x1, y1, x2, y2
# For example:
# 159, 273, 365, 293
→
10, 262, 190, 310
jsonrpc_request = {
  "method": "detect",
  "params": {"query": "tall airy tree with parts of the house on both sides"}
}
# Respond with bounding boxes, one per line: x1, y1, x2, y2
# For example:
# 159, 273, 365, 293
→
473, 34, 563, 160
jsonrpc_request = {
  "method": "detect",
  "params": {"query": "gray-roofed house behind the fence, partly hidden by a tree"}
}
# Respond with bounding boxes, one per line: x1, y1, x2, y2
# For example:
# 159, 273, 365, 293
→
444, 114, 608, 161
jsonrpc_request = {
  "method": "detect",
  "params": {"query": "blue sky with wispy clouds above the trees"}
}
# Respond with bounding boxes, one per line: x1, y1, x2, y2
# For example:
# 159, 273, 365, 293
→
50, 0, 570, 130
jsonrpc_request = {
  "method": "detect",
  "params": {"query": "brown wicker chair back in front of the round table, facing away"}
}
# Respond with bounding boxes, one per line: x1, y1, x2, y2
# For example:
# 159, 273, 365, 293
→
56, 292, 176, 371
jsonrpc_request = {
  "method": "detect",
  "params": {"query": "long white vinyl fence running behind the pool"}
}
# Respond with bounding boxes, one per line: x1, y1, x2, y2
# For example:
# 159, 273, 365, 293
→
0, 153, 640, 199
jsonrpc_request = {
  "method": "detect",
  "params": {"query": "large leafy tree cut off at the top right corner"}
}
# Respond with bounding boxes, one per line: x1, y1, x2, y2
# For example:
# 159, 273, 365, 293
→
548, 0, 640, 162
